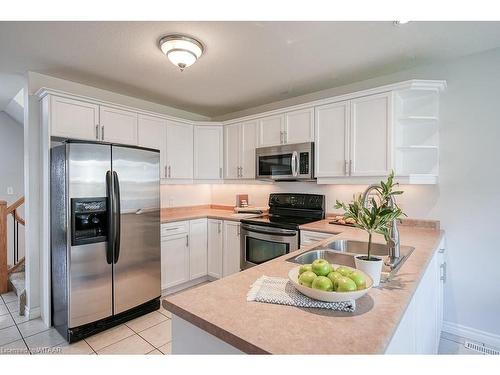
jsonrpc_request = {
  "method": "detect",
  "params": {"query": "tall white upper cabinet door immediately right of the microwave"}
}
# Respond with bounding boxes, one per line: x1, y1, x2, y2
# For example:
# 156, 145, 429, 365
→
315, 101, 349, 177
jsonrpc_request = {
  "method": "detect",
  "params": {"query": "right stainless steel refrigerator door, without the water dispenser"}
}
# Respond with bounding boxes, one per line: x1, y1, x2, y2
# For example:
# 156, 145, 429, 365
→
112, 146, 161, 314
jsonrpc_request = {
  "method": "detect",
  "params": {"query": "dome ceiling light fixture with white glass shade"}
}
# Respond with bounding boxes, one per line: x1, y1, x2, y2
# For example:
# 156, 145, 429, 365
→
159, 34, 204, 72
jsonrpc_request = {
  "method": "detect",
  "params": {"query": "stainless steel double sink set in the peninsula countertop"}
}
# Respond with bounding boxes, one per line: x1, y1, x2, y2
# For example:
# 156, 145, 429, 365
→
287, 240, 415, 279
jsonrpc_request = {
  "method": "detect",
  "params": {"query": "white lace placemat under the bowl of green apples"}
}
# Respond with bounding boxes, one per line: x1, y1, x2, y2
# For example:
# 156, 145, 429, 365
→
247, 276, 356, 312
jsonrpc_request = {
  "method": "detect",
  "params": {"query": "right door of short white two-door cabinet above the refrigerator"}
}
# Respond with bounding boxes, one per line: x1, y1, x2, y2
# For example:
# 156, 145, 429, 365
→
99, 106, 137, 145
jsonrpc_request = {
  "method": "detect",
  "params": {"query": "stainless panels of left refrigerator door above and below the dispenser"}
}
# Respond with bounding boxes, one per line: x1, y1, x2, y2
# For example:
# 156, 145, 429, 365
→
67, 143, 113, 328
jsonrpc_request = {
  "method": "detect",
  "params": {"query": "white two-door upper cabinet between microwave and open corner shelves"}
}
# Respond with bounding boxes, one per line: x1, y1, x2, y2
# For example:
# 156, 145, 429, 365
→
315, 93, 393, 178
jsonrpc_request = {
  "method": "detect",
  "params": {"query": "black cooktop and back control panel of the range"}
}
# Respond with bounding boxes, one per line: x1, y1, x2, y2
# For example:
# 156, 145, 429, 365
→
241, 193, 325, 229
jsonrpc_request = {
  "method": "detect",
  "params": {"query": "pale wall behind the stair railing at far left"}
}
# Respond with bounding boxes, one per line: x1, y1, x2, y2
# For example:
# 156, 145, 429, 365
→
0, 111, 24, 265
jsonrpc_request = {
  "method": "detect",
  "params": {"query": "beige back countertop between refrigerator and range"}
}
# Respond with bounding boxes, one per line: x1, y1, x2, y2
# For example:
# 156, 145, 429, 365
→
160, 205, 264, 224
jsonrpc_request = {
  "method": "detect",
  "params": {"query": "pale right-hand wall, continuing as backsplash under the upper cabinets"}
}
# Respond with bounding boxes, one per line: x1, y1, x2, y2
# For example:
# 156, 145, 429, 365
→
166, 49, 500, 340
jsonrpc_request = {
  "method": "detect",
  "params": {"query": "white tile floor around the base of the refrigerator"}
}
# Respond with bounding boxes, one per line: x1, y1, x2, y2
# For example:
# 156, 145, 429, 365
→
0, 293, 172, 354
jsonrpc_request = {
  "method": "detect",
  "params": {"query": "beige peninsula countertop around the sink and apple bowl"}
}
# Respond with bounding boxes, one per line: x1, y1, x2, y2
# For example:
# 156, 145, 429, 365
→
163, 223, 443, 354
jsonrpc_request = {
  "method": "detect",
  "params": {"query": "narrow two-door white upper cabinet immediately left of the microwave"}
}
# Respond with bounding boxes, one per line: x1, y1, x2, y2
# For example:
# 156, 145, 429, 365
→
224, 121, 257, 179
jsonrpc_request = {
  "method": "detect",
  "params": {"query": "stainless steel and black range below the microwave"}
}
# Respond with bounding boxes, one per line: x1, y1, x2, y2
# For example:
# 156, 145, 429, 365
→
240, 193, 325, 269
